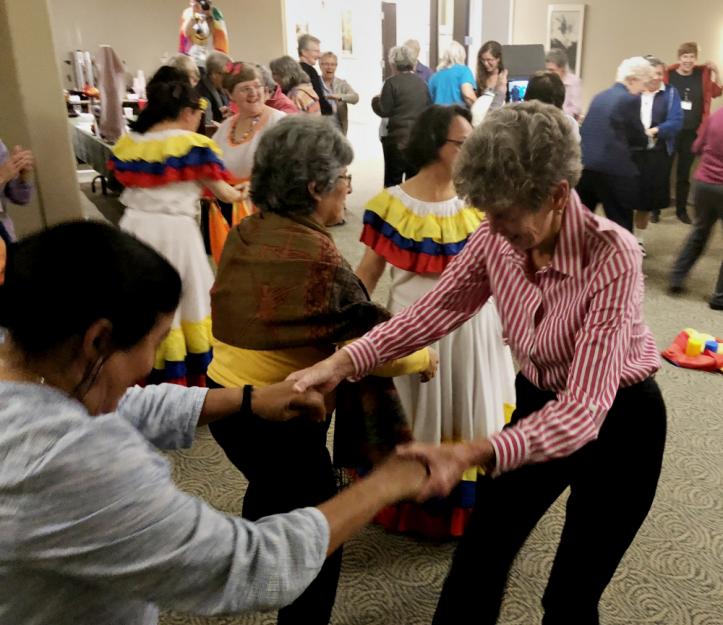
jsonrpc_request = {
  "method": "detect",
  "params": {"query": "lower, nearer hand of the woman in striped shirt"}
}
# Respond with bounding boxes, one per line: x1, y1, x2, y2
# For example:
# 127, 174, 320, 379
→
397, 443, 486, 501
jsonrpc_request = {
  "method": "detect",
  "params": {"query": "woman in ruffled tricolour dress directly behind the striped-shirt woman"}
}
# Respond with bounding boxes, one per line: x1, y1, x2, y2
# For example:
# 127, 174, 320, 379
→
356, 105, 515, 537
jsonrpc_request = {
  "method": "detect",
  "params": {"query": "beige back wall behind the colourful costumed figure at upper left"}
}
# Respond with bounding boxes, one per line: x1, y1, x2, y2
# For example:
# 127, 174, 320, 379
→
48, 0, 285, 84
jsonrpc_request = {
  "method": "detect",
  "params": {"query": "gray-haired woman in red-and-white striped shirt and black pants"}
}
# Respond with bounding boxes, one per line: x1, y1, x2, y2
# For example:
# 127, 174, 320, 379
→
294, 102, 666, 625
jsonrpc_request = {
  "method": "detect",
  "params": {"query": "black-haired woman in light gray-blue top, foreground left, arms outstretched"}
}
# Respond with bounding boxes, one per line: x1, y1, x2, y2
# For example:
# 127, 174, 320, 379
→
0, 222, 424, 625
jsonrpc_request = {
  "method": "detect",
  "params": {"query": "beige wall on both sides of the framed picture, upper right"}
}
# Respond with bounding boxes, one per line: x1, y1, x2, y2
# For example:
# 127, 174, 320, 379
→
513, 0, 723, 112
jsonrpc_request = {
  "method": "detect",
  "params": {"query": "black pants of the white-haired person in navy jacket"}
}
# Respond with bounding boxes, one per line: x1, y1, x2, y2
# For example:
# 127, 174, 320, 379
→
577, 169, 640, 232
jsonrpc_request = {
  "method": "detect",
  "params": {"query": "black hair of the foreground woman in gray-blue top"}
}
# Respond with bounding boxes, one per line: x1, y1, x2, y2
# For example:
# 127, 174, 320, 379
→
0, 221, 181, 356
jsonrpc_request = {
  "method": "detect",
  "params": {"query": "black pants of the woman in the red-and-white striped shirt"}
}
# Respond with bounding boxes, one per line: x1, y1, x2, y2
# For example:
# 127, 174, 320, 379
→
433, 374, 665, 625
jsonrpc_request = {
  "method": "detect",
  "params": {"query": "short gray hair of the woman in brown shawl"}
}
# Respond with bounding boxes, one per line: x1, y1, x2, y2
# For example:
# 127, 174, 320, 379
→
251, 115, 354, 215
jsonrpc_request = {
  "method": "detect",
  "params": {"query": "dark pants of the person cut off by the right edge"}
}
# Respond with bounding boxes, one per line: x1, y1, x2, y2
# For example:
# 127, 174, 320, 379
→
670, 182, 723, 306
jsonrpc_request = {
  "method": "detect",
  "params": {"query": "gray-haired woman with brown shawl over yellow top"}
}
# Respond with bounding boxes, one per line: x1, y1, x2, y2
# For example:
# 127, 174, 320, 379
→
208, 115, 436, 625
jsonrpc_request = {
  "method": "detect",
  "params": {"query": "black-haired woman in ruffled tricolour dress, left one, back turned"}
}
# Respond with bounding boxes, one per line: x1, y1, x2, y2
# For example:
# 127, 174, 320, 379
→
110, 67, 241, 386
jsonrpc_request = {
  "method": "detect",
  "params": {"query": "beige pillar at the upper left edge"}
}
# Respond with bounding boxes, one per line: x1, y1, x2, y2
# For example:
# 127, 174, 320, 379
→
0, 0, 82, 235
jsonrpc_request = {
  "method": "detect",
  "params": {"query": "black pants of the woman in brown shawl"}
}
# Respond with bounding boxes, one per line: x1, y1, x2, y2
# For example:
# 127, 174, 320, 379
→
208, 380, 342, 625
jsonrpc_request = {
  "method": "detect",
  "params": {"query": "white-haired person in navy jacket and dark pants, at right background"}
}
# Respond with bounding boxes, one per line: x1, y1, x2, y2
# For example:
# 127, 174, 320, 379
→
577, 57, 653, 232
